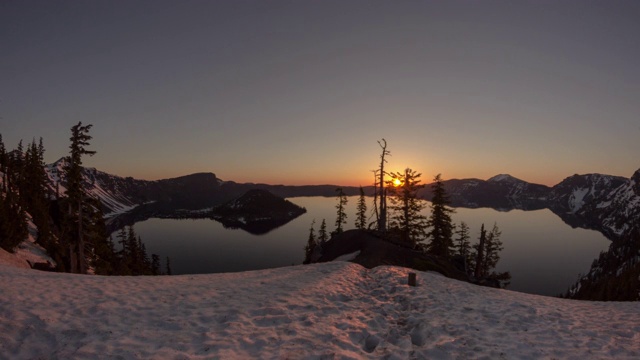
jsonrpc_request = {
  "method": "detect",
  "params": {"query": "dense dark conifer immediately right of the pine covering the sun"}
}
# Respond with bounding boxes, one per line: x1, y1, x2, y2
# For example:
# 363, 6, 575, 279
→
427, 174, 454, 259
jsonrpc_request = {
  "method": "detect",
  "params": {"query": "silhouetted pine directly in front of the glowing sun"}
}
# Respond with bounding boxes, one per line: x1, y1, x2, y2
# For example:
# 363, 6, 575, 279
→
387, 168, 426, 246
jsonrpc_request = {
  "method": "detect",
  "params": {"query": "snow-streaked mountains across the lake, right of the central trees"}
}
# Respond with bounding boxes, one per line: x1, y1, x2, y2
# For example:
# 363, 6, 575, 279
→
423, 170, 640, 243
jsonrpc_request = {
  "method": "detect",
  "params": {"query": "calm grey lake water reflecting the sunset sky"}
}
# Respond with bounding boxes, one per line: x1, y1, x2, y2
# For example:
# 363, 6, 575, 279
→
126, 197, 609, 295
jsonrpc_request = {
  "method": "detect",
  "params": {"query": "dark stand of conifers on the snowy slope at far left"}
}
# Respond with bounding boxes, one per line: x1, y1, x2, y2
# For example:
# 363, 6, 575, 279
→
0, 122, 170, 275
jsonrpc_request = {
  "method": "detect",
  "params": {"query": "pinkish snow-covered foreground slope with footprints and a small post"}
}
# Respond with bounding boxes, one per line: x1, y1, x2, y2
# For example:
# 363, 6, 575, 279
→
0, 262, 640, 359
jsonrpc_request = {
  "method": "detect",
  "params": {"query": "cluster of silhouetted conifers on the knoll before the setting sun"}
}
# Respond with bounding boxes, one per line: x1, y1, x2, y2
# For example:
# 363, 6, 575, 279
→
304, 139, 511, 284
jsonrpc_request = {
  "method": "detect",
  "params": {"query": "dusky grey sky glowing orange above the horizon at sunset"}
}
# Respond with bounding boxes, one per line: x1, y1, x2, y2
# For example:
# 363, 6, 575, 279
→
0, 0, 640, 185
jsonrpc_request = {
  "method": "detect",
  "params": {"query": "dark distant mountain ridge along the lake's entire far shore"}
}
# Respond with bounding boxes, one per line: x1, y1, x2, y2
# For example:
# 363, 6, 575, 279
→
47, 158, 640, 236
